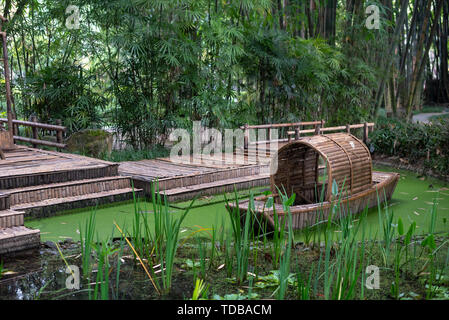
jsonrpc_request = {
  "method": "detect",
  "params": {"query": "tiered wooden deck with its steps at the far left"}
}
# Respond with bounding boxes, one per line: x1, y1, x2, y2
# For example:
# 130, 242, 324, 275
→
0, 146, 141, 254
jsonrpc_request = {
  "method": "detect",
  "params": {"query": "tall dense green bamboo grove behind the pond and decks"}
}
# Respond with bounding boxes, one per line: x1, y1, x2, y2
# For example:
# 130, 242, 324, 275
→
0, 0, 449, 149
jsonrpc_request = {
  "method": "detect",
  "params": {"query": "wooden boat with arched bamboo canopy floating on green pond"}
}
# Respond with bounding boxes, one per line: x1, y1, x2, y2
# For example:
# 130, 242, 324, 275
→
227, 133, 399, 229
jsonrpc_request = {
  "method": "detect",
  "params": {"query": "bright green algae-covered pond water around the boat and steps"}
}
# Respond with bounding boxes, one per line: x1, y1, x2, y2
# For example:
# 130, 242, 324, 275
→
25, 167, 449, 241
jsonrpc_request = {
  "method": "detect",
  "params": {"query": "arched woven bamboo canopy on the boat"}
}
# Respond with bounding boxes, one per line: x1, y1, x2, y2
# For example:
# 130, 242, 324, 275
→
271, 133, 372, 204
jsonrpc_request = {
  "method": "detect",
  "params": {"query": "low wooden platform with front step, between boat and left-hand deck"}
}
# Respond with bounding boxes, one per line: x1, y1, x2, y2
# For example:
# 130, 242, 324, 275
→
119, 155, 269, 202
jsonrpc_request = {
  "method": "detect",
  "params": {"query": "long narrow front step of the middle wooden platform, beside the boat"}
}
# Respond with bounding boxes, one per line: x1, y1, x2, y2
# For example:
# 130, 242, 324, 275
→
159, 173, 270, 202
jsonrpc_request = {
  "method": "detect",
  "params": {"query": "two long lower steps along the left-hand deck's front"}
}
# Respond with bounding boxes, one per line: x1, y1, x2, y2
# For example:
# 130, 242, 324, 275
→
7, 177, 142, 218
